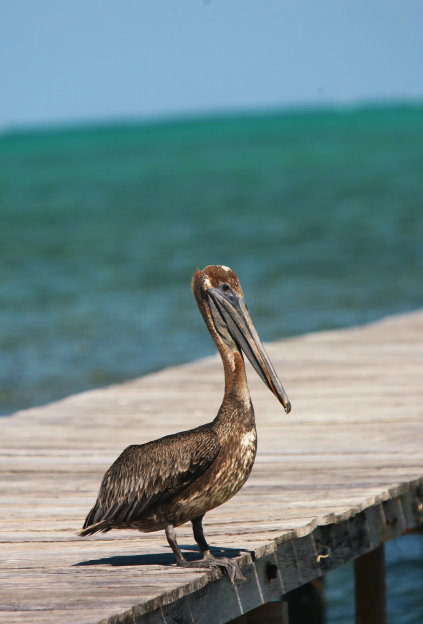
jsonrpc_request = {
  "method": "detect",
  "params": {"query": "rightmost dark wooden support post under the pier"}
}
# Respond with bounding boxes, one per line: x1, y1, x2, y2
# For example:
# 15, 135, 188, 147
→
354, 544, 386, 624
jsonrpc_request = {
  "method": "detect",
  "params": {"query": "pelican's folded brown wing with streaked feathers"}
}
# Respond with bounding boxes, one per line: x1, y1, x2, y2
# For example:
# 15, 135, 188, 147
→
82, 427, 220, 535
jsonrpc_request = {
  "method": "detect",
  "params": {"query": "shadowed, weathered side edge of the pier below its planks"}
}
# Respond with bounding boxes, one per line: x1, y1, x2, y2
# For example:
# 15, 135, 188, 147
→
99, 478, 423, 624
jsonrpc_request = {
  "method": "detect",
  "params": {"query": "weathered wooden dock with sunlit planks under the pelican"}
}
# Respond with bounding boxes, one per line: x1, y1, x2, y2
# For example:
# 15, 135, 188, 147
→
0, 312, 423, 624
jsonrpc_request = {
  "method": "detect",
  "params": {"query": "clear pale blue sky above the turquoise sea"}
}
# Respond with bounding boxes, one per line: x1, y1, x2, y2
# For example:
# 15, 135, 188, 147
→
0, 0, 423, 128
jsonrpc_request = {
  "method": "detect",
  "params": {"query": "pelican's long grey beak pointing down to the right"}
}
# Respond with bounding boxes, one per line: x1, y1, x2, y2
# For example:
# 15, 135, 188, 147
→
207, 287, 291, 414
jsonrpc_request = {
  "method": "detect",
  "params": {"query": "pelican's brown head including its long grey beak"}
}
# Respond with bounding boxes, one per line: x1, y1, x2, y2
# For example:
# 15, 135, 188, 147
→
192, 265, 291, 414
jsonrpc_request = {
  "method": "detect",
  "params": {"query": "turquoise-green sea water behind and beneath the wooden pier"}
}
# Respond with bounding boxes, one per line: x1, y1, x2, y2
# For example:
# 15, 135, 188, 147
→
0, 105, 423, 624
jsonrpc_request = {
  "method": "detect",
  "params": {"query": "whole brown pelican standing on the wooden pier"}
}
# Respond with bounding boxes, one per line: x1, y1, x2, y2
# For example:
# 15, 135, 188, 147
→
79, 265, 291, 580
